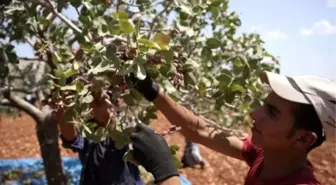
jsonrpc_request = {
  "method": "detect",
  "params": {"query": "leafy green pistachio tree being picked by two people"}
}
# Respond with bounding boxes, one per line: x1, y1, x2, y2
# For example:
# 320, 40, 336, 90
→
0, 0, 279, 184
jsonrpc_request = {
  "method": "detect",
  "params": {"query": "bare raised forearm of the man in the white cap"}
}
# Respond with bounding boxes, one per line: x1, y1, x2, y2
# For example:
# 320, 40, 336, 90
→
153, 92, 243, 160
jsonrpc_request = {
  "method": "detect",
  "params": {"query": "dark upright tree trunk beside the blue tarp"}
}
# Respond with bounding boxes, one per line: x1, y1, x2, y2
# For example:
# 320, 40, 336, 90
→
36, 113, 67, 185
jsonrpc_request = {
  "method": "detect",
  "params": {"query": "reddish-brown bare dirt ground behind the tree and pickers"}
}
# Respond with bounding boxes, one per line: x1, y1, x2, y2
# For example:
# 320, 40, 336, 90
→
0, 112, 336, 185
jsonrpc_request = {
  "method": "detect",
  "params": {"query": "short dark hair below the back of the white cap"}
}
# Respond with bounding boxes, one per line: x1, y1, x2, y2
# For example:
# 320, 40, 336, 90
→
294, 103, 326, 152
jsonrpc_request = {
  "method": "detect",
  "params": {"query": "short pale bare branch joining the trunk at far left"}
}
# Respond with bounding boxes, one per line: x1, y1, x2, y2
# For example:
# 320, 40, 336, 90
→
3, 90, 43, 123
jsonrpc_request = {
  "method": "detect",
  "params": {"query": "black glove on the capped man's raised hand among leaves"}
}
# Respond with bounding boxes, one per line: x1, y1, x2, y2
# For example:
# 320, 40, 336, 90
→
130, 73, 159, 101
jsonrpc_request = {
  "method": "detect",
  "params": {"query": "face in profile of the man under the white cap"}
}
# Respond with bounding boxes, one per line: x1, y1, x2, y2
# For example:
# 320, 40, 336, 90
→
250, 92, 295, 151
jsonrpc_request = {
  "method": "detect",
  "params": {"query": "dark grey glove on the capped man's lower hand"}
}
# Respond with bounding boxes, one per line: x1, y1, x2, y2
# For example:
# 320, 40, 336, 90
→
131, 123, 179, 184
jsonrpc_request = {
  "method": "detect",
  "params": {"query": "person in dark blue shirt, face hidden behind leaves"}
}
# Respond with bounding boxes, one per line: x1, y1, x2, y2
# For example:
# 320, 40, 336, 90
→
51, 91, 144, 185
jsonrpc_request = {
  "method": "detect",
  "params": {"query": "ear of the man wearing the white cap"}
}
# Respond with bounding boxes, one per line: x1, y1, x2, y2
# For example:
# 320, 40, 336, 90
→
295, 130, 317, 150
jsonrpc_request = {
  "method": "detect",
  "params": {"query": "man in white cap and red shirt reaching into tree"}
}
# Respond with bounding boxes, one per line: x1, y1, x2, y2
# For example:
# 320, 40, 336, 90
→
127, 72, 336, 185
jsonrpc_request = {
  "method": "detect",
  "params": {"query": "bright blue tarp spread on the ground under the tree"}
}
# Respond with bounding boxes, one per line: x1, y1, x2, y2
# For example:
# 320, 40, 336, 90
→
0, 157, 191, 185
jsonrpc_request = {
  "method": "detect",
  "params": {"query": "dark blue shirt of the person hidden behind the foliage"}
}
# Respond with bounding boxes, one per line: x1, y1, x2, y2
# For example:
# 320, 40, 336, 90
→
61, 133, 144, 185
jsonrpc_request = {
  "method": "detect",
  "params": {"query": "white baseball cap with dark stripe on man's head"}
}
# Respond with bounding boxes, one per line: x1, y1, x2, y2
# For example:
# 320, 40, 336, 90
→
261, 72, 336, 137
